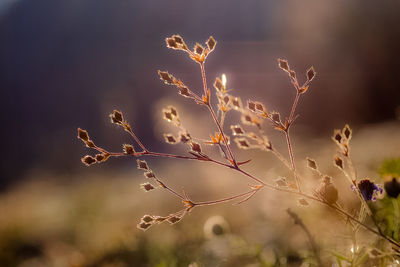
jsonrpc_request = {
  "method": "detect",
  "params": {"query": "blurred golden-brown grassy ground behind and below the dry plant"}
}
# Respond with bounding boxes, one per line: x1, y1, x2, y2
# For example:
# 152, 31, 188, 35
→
0, 123, 400, 266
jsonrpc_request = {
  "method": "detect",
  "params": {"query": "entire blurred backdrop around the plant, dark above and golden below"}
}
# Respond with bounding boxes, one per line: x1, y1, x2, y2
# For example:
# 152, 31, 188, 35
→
0, 0, 400, 266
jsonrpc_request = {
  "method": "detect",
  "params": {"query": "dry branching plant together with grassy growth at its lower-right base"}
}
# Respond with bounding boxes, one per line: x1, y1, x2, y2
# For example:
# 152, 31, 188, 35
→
71, 35, 400, 266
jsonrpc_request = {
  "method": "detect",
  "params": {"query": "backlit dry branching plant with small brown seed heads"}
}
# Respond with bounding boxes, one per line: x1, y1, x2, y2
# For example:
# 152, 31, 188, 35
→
78, 35, 400, 264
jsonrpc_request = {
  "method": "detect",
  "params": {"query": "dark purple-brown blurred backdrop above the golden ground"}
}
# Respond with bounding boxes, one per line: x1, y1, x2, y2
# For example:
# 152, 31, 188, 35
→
0, 0, 400, 189
